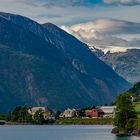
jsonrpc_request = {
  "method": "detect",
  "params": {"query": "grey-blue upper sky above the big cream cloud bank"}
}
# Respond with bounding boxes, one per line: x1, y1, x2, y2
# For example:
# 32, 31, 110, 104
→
0, 0, 140, 26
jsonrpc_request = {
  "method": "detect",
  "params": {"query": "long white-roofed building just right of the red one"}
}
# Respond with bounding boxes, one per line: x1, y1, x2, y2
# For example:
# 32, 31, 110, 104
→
100, 106, 116, 118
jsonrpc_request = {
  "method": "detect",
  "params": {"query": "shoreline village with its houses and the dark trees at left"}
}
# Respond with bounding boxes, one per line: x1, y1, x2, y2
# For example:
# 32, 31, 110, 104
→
0, 106, 116, 125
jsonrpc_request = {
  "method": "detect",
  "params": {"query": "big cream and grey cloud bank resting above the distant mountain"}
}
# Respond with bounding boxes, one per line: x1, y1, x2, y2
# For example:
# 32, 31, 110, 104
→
61, 19, 140, 47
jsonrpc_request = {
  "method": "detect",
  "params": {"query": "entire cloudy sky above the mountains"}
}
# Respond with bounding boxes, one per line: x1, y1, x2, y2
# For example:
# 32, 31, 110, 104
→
0, 0, 140, 48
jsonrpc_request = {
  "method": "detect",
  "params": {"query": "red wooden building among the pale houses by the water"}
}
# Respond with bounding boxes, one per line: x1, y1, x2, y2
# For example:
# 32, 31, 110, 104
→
85, 108, 104, 118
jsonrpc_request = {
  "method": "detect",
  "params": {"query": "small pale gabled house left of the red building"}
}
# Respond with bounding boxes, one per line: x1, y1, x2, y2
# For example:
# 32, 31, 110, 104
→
60, 108, 76, 118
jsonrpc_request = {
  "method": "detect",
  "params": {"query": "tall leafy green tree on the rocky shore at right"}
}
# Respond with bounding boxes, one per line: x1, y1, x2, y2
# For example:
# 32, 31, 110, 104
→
114, 92, 137, 133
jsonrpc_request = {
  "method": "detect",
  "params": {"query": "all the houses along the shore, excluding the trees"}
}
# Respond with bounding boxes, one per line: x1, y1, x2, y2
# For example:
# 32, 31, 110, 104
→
28, 106, 116, 120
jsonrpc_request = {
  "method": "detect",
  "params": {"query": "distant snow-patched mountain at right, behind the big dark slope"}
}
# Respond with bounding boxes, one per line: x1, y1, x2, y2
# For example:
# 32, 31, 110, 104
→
95, 49, 140, 84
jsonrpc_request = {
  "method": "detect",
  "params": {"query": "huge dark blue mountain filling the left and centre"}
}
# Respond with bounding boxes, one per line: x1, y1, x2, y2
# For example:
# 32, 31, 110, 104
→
0, 13, 130, 112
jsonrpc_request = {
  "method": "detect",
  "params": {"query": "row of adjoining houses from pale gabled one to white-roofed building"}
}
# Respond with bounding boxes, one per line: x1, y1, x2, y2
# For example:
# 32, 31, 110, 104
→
59, 106, 116, 118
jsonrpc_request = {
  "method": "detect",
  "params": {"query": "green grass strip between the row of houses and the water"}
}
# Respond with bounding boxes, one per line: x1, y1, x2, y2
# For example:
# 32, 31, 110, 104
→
56, 118, 112, 124
